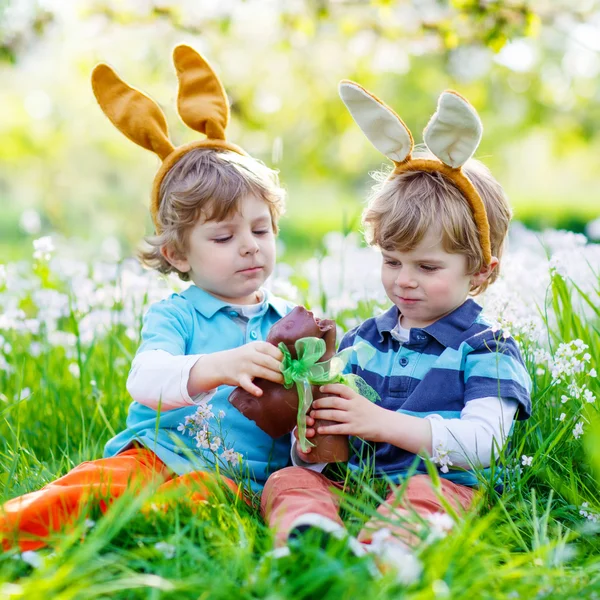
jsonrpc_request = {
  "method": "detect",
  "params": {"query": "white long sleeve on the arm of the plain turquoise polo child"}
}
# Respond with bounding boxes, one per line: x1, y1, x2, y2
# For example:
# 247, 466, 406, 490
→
127, 350, 215, 412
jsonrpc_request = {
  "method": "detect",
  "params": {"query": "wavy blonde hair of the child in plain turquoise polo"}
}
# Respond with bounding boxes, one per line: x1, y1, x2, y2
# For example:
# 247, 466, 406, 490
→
138, 148, 285, 281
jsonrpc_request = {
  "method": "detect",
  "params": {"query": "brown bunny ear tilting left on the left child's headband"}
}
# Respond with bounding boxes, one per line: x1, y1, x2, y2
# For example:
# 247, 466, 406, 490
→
92, 64, 174, 160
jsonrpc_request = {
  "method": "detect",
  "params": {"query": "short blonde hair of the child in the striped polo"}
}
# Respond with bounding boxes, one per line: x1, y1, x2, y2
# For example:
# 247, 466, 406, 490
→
362, 153, 512, 295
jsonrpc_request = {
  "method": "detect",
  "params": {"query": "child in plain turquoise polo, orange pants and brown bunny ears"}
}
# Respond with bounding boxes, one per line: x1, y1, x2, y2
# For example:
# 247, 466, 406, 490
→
0, 46, 293, 550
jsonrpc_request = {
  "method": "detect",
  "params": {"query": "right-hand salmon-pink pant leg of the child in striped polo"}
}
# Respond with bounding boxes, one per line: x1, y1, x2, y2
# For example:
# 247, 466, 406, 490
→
358, 475, 475, 547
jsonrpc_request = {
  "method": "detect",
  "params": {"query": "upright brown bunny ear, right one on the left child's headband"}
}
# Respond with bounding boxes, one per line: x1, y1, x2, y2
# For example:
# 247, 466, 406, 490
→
173, 44, 229, 140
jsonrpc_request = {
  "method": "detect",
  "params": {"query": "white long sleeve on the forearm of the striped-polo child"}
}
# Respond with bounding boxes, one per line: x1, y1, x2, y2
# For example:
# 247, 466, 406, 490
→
425, 396, 519, 473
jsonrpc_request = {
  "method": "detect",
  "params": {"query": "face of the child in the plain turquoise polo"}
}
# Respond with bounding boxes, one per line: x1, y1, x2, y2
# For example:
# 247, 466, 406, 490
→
165, 195, 275, 304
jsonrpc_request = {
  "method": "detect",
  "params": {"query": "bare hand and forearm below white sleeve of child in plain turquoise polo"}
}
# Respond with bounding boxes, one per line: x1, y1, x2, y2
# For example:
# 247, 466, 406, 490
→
188, 342, 283, 396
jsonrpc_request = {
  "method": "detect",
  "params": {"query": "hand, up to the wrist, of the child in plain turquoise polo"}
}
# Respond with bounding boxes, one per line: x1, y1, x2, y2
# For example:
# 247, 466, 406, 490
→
220, 342, 283, 396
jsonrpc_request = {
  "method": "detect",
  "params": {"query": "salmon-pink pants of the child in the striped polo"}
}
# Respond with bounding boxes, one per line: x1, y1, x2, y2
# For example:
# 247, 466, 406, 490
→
261, 467, 475, 546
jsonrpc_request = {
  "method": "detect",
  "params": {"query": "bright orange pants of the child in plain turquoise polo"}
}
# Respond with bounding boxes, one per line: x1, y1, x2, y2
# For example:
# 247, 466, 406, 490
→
0, 448, 239, 551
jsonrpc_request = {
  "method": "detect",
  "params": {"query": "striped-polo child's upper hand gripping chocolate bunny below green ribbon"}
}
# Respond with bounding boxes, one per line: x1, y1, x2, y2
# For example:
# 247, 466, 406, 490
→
309, 383, 390, 442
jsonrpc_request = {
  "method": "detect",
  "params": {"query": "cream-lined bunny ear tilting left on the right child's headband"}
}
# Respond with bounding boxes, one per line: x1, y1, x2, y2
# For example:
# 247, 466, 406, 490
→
339, 79, 414, 164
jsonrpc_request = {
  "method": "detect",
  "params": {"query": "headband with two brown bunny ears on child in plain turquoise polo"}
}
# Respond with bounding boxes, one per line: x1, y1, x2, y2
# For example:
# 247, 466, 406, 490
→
92, 45, 246, 233
